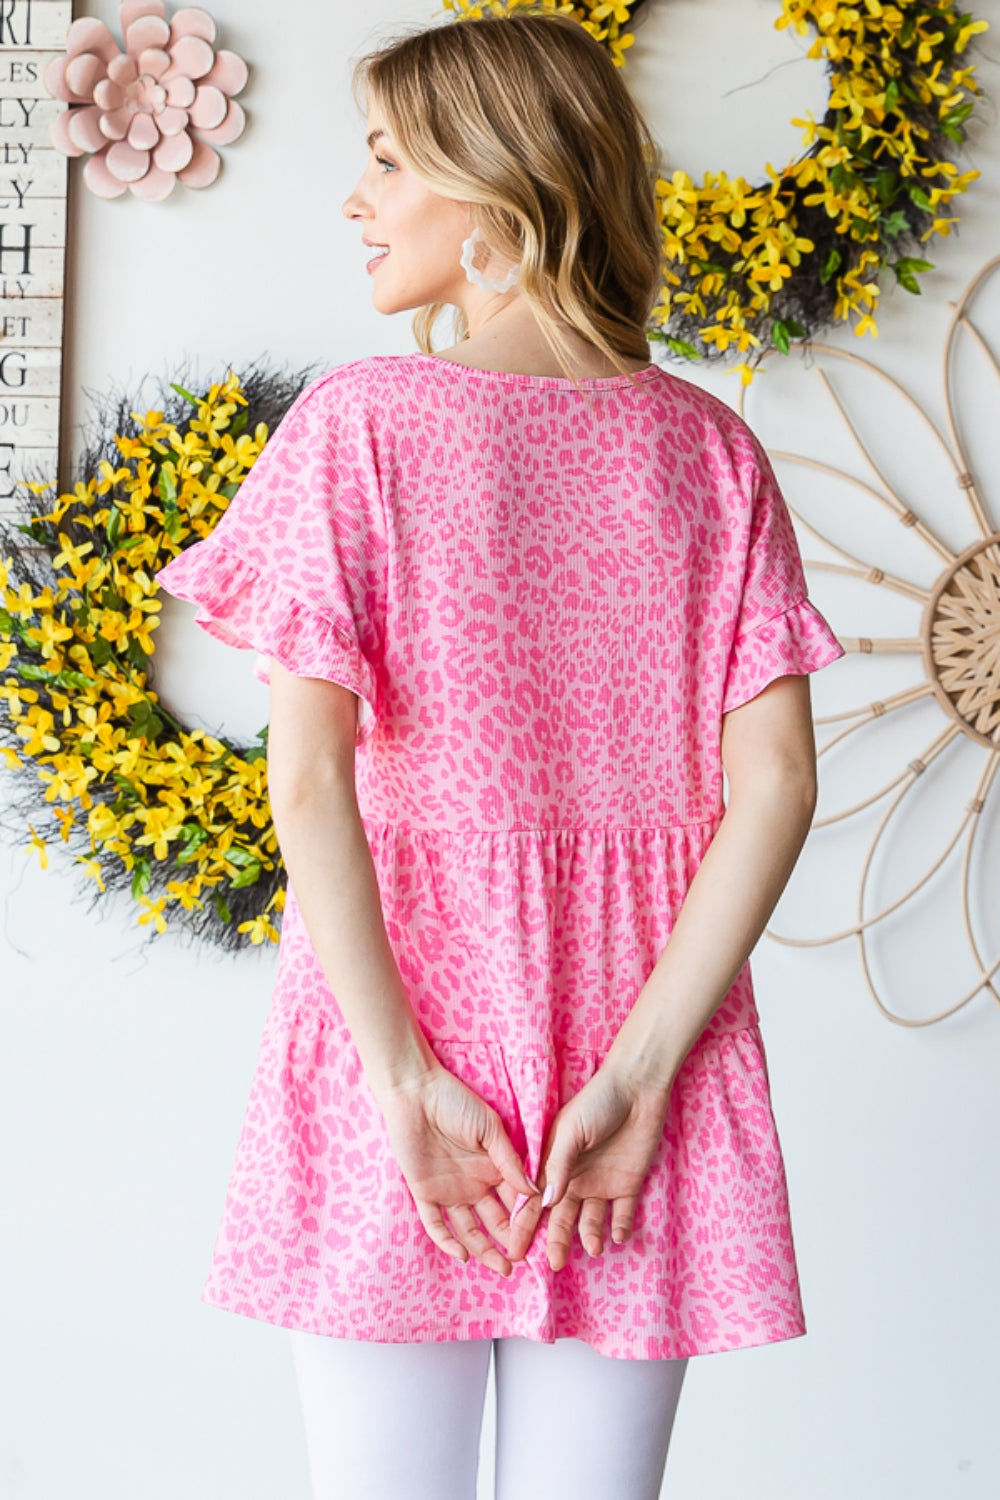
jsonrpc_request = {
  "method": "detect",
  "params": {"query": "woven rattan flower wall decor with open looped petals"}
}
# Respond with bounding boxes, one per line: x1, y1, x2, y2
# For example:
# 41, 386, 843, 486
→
739, 255, 1000, 1026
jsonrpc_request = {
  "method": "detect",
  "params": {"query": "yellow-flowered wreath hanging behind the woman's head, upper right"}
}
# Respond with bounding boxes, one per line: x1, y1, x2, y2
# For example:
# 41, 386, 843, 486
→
444, 0, 988, 386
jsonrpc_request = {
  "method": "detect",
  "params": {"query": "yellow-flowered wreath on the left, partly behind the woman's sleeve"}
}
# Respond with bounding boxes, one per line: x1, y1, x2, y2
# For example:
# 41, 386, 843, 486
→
0, 371, 319, 948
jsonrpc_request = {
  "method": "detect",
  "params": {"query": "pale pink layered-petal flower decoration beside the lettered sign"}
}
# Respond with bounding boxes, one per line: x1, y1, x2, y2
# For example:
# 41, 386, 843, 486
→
43, 0, 247, 201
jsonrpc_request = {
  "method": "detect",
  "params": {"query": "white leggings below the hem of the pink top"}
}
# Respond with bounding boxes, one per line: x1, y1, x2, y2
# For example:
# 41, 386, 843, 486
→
289, 1331, 687, 1500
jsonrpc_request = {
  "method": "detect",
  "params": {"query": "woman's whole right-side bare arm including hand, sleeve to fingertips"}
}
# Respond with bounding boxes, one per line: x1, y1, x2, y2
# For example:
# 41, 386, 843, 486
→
507, 675, 816, 1271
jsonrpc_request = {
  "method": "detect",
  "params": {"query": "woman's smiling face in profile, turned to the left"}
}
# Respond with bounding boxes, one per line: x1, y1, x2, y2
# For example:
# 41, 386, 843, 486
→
343, 105, 514, 314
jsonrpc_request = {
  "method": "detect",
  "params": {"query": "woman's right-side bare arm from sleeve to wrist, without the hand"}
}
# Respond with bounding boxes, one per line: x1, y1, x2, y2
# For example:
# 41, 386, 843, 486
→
604, 675, 816, 1088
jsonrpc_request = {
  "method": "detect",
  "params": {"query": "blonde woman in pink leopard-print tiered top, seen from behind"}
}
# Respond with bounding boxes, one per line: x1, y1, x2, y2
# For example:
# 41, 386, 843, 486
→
159, 11, 843, 1500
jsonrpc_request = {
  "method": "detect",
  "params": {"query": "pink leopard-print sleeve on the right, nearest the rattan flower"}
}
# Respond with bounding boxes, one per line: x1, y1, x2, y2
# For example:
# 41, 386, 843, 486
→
723, 429, 844, 714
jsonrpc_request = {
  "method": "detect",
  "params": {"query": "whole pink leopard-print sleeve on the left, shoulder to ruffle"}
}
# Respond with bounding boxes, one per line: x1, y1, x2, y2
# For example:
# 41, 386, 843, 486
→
156, 365, 388, 743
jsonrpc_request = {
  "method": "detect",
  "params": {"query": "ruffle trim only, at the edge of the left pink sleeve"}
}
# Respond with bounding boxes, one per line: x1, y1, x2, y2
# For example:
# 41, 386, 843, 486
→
156, 536, 378, 744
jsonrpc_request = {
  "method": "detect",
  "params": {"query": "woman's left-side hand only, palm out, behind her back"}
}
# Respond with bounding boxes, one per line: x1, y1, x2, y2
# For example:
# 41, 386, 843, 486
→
371, 1064, 538, 1277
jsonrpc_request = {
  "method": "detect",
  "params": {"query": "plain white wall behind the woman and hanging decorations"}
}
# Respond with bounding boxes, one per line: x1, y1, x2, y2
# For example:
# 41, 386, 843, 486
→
0, 0, 1000, 1500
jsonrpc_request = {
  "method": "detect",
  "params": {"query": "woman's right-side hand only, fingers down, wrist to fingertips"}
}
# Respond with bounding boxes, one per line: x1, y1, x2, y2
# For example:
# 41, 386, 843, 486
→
508, 1068, 670, 1271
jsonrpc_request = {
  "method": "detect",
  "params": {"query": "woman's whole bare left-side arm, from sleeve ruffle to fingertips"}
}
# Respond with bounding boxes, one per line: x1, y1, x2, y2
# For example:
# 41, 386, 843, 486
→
260, 662, 540, 1277
